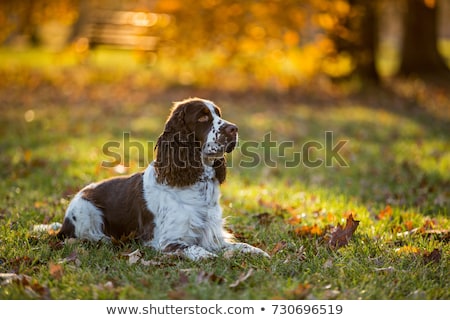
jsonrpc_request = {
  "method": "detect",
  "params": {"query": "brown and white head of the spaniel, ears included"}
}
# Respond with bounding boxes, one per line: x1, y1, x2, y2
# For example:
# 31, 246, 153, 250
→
155, 98, 238, 186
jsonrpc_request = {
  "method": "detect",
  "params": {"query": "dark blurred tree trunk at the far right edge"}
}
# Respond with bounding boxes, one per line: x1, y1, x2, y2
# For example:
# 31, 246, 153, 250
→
398, 0, 450, 79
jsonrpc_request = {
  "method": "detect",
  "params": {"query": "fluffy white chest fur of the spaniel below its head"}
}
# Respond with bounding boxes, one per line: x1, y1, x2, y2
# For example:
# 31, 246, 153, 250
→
144, 164, 225, 250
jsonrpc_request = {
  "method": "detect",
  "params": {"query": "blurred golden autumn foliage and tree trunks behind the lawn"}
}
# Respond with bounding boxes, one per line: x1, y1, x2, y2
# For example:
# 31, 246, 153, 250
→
0, 0, 450, 92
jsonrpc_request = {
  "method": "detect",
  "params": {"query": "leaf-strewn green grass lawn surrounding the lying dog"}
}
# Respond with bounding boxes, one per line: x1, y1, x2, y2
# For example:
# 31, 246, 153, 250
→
0, 48, 450, 299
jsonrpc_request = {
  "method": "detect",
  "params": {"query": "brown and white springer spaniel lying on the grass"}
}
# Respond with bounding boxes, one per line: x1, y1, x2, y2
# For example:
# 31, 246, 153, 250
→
58, 98, 269, 260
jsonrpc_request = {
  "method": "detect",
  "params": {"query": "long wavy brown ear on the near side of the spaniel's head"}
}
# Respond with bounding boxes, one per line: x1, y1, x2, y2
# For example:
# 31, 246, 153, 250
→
155, 106, 203, 187
